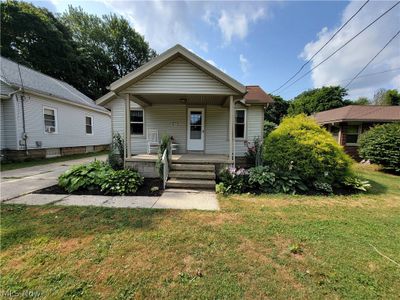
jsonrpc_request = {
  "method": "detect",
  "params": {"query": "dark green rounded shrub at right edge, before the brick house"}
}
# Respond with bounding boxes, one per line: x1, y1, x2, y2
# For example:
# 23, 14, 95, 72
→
359, 123, 400, 173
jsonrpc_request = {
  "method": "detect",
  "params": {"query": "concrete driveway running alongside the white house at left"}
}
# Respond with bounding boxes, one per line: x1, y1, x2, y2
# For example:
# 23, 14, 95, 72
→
0, 155, 107, 202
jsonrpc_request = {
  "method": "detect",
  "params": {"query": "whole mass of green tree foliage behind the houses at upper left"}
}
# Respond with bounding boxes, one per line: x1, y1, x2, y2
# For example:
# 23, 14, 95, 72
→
0, 1, 156, 99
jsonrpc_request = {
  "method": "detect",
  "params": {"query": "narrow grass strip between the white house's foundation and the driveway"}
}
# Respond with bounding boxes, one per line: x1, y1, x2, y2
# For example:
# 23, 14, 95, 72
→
1, 151, 108, 171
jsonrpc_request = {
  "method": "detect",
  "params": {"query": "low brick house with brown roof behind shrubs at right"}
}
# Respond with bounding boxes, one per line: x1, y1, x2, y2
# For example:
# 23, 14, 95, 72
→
314, 105, 400, 160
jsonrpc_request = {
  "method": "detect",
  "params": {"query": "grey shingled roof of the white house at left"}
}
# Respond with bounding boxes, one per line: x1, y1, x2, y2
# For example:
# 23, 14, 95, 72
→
0, 56, 108, 112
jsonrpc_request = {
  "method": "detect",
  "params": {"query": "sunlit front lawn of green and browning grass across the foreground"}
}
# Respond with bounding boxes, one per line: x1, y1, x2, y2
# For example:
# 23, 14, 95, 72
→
0, 168, 400, 299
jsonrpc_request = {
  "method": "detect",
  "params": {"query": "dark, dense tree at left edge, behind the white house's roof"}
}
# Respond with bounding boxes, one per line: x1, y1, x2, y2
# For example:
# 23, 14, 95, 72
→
0, 1, 82, 88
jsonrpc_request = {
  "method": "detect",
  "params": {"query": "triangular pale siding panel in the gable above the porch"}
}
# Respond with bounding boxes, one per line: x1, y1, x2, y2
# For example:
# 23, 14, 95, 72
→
124, 58, 237, 95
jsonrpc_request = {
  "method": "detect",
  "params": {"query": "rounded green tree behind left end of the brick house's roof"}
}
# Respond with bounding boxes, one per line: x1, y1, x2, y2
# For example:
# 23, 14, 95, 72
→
288, 86, 351, 115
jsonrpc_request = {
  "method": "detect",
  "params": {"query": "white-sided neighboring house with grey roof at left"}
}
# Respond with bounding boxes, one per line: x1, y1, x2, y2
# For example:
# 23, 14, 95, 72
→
0, 57, 111, 160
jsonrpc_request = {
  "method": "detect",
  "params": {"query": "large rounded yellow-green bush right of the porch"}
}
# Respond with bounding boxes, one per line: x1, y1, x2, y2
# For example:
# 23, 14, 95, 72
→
264, 115, 351, 189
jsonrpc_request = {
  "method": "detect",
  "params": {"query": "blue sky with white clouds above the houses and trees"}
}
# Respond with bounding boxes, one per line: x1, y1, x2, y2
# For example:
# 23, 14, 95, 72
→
33, 0, 400, 99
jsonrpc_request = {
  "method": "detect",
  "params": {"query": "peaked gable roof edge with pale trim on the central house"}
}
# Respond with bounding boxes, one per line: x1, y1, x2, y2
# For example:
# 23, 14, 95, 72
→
96, 44, 246, 105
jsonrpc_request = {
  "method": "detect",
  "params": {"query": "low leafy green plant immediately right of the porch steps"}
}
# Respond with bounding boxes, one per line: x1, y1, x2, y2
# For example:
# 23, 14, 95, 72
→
217, 167, 248, 194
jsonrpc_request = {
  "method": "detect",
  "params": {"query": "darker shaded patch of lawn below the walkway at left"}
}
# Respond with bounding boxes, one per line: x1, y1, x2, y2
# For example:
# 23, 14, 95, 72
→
0, 205, 178, 251
